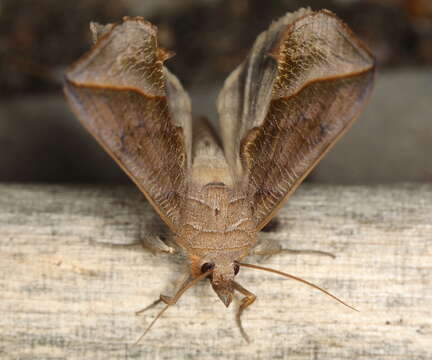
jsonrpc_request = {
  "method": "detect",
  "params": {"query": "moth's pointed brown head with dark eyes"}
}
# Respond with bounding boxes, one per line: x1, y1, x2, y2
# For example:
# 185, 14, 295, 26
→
201, 262, 240, 307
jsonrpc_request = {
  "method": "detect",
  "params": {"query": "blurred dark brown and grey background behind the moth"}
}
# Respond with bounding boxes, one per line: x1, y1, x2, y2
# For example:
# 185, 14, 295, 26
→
0, 0, 432, 184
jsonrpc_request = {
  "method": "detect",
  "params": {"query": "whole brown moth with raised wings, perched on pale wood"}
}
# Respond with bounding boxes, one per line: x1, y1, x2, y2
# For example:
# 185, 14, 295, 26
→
64, 9, 375, 339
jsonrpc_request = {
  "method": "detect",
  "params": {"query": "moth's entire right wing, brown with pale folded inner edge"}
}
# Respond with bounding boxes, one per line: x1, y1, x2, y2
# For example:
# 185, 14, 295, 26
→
217, 9, 374, 229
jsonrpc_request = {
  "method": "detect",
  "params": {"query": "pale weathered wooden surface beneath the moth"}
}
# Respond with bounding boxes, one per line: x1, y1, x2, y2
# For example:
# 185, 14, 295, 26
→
0, 184, 432, 360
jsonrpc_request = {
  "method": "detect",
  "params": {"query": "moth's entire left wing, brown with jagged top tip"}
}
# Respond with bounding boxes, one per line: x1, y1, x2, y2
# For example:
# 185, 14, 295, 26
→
64, 18, 191, 230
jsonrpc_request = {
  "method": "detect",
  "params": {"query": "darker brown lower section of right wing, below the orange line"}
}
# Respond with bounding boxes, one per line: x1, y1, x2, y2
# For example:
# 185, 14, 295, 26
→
241, 73, 373, 227
